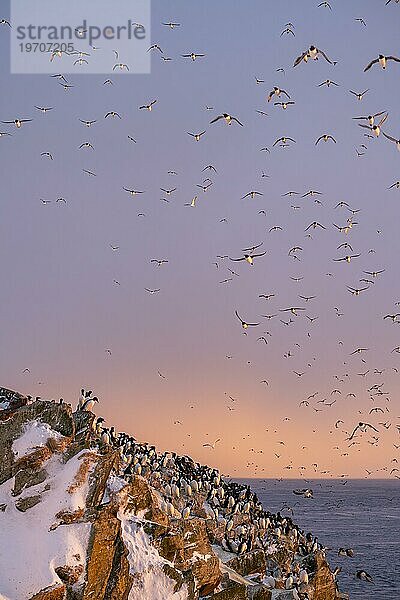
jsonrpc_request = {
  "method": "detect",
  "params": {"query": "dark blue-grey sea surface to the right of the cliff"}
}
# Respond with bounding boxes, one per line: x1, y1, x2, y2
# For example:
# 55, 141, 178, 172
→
241, 479, 400, 600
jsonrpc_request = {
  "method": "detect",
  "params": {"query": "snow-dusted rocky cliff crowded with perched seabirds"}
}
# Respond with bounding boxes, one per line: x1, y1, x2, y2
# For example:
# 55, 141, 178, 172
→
0, 389, 341, 600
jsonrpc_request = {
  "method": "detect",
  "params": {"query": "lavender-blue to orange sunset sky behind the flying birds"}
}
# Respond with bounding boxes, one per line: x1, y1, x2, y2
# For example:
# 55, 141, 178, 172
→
0, 0, 400, 478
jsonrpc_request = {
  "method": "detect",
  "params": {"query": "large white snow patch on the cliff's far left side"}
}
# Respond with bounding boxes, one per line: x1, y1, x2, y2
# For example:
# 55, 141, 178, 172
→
0, 450, 91, 600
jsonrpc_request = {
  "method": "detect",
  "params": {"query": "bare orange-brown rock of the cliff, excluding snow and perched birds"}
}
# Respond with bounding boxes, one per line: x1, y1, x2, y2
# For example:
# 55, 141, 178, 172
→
0, 388, 341, 600
